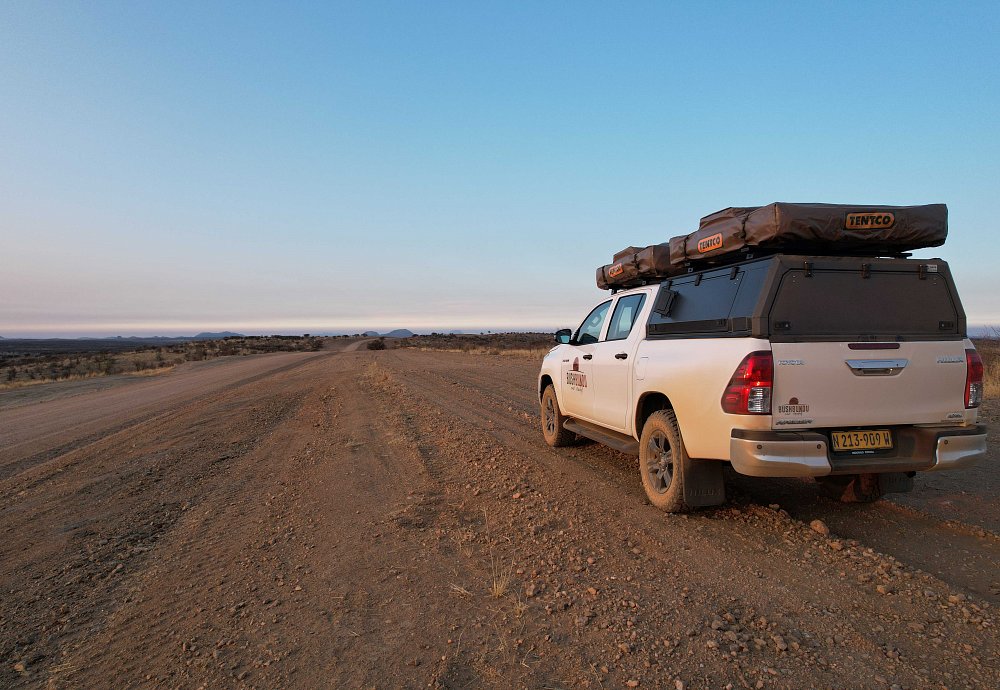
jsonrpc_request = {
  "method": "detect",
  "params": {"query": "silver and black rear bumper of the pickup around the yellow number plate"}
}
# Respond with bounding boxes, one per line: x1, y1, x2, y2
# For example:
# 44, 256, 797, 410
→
729, 426, 986, 477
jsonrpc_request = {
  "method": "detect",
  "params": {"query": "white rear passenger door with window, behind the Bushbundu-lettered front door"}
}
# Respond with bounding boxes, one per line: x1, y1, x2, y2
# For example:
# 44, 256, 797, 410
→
592, 292, 647, 433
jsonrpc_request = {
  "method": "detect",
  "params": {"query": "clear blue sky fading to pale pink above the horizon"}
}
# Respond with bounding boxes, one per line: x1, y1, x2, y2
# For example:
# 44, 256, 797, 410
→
0, 0, 1000, 337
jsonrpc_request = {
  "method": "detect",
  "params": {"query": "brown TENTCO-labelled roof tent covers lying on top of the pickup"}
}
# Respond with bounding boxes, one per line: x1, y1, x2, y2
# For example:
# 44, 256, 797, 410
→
597, 203, 948, 290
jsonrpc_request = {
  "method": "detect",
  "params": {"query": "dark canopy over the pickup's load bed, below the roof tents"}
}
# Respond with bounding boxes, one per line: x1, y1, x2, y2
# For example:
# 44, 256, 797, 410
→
647, 254, 966, 342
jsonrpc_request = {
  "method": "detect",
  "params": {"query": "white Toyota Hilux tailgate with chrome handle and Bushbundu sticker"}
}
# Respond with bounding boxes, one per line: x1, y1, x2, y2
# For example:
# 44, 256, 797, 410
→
772, 340, 966, 429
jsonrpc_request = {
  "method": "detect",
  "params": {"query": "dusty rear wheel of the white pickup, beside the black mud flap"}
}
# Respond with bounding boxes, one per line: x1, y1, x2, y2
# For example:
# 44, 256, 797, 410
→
639, 410, 690, 513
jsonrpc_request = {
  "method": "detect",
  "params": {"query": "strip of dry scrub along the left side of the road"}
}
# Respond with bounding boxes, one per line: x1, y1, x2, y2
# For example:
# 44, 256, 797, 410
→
0, 335, 323, 389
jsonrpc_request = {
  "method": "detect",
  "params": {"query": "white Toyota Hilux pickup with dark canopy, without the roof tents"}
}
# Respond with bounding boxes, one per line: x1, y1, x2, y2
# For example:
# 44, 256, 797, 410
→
538, 254, 986, 512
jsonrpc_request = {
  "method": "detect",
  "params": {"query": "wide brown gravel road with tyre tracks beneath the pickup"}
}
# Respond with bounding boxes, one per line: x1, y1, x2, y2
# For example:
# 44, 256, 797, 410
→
0, 350, 1000, 690
